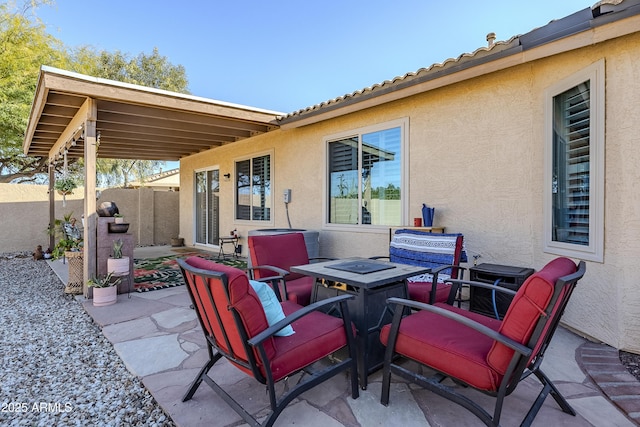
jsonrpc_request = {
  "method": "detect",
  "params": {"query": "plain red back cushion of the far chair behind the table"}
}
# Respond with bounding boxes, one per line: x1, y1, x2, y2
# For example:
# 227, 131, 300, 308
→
249, 233, 309, 281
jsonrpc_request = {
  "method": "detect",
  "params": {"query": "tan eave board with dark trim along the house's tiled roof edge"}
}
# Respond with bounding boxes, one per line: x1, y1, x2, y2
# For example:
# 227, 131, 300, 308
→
280, 5, 640, 130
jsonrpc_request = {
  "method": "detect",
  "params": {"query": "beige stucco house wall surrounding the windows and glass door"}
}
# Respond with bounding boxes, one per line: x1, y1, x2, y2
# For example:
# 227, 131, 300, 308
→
180, 34, 640, 352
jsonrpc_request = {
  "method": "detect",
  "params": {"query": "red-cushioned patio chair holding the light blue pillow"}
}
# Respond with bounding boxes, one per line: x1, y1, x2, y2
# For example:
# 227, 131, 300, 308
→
178, 257, 358, 426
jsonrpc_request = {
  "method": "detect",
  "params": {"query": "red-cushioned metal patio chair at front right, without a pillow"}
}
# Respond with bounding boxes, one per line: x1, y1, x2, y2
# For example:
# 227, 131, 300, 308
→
380, 258, 586, 426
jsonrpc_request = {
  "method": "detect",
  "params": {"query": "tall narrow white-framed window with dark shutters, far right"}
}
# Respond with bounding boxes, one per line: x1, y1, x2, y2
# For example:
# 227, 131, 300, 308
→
544, 60, 605, 262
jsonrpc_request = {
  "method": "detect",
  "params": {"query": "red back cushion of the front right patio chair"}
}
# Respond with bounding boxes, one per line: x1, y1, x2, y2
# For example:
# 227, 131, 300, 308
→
487, 258, 576, 375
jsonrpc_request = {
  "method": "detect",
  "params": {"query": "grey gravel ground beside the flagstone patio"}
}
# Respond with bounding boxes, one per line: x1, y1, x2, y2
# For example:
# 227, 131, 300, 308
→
0, 253, 174, 426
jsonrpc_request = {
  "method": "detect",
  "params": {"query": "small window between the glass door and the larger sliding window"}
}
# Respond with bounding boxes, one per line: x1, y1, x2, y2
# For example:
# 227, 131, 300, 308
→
235, 153, 273, 222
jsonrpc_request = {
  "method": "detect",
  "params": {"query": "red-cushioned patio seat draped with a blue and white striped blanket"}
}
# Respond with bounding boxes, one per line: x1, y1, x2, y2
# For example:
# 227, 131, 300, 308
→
373, 229, 466, 304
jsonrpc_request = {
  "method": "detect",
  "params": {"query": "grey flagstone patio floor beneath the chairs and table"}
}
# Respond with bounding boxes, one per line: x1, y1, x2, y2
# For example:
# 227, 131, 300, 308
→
47, 247, 640, 427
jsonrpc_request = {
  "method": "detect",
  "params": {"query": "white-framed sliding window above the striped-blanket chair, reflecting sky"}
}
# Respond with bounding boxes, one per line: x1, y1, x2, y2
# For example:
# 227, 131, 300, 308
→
323, 118, 409, 228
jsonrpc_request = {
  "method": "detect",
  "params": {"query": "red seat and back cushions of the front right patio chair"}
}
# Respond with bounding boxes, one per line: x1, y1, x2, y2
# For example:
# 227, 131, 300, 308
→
380, 258, 576, 391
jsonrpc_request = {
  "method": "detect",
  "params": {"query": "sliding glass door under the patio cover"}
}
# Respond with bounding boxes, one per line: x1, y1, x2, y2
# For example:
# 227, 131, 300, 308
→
194, 169, 220, 245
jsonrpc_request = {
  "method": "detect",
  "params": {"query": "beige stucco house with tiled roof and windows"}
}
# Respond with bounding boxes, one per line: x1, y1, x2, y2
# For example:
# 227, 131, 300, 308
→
25, 0, 640, 352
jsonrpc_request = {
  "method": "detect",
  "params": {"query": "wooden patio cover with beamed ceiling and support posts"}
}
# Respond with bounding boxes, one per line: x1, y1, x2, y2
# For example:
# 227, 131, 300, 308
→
23, 66, 283, 294
